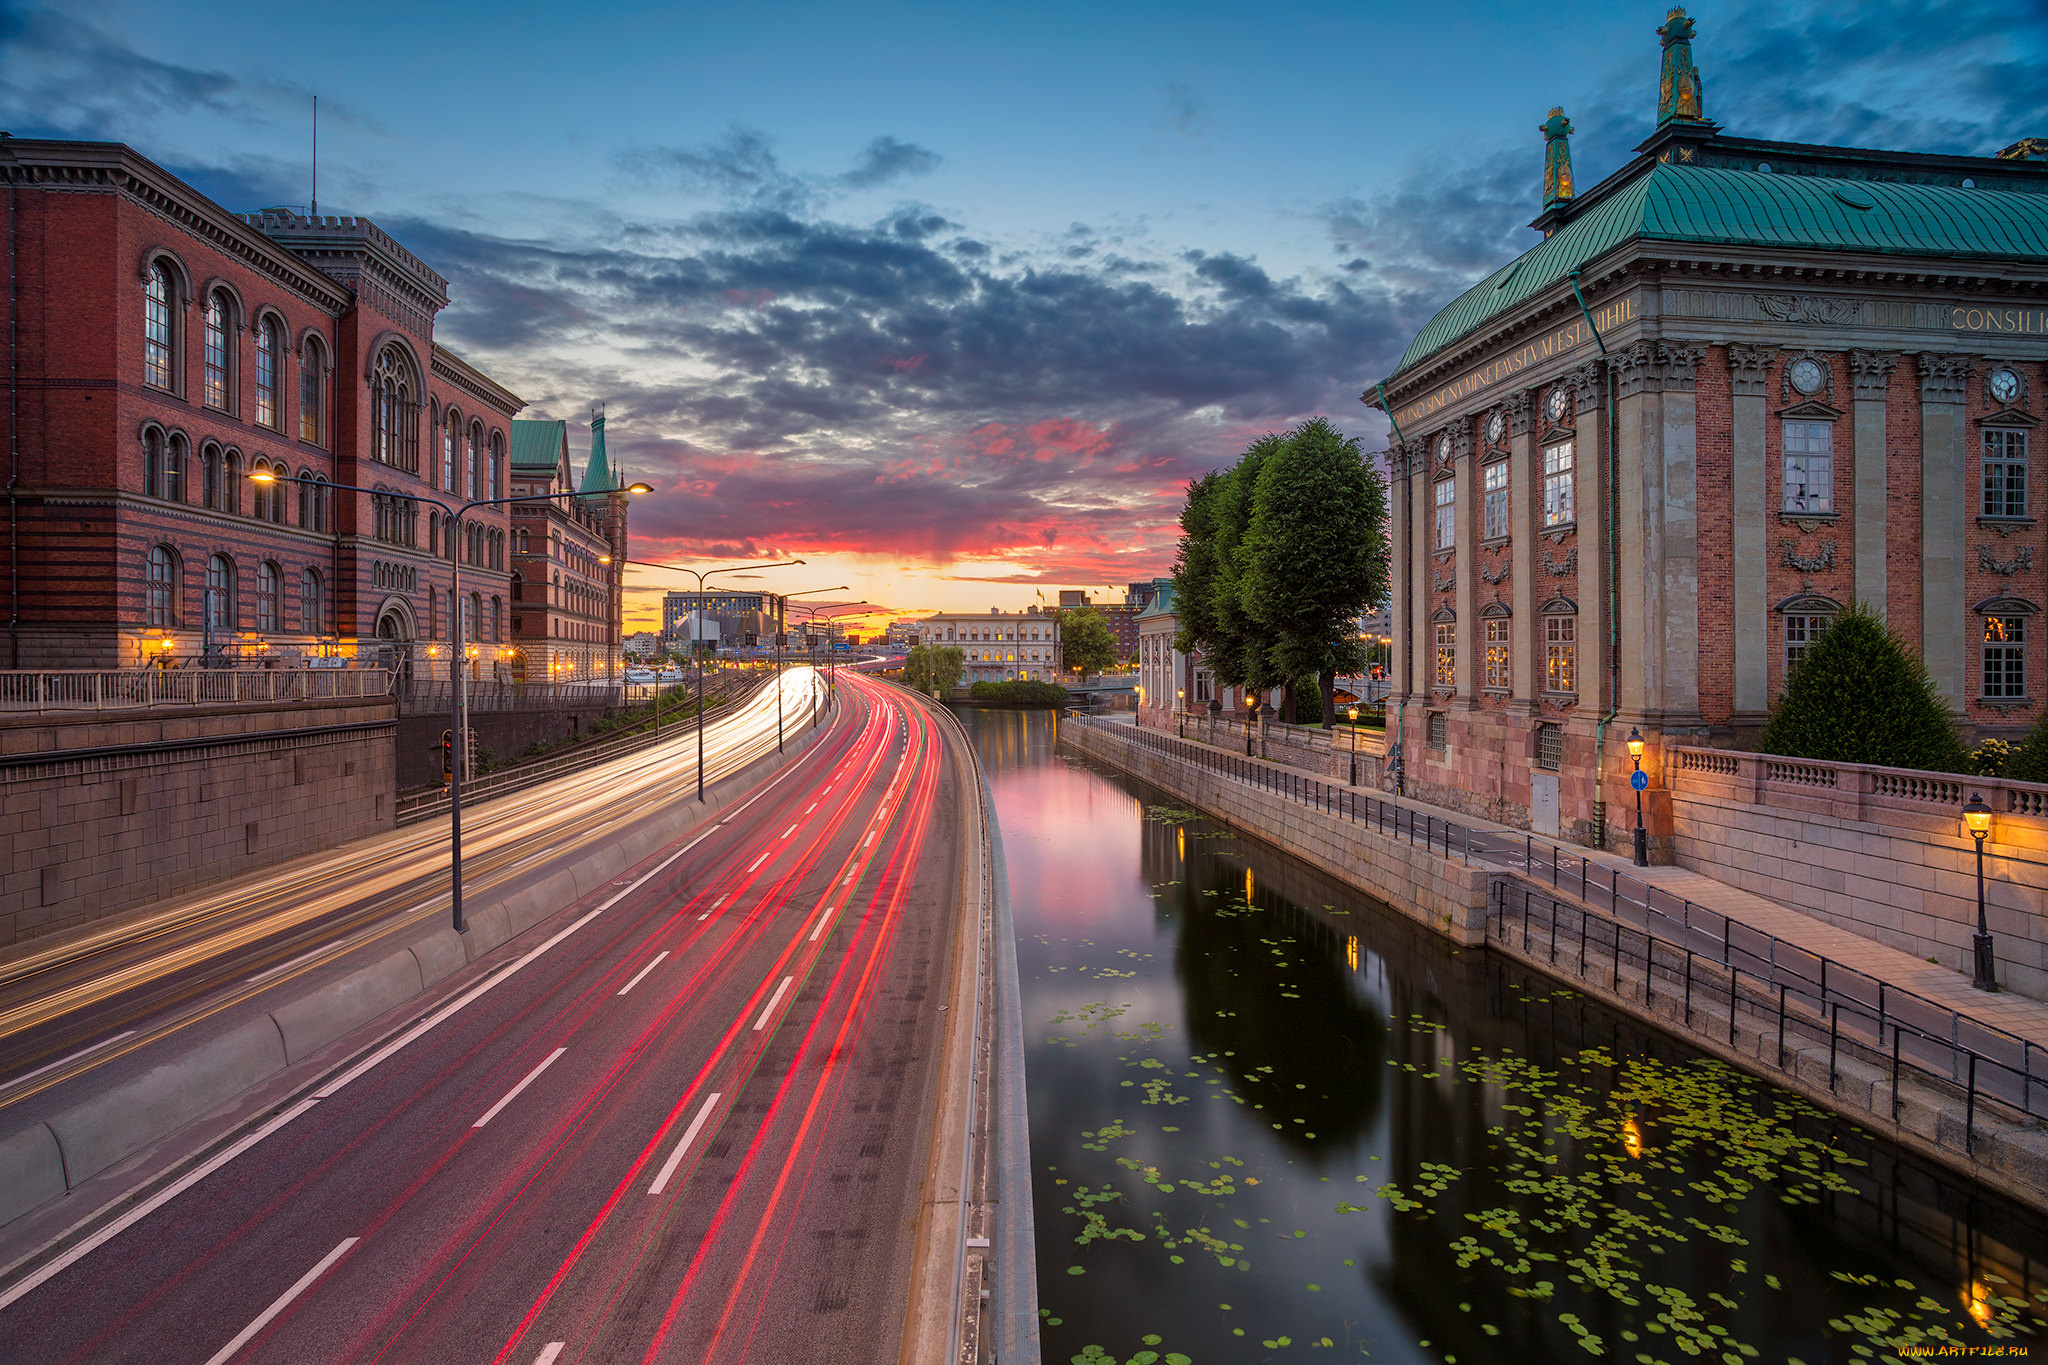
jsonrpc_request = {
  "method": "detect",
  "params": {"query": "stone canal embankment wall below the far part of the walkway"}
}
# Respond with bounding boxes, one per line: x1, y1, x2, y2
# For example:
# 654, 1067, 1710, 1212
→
1059, 720, 1491, 943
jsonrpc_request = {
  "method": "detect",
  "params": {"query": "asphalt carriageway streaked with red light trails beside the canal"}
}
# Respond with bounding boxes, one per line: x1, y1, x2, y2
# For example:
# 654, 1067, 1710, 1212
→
0, 675, 971, 1365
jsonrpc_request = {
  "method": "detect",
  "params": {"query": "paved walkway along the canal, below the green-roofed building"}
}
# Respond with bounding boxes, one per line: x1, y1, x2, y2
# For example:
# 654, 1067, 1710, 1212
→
1122, 726, 2048, 1048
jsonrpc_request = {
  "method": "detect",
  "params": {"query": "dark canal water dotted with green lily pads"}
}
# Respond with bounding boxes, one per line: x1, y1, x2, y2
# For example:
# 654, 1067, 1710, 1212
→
963, 710, 2048, 1365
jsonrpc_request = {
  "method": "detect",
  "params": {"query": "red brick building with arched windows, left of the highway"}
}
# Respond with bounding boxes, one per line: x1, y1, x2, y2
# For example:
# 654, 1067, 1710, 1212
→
0, 137, 522, 675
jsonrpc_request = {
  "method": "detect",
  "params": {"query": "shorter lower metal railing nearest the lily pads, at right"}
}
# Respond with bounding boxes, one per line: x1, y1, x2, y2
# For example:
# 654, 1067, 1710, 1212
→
1487, 878, 2048, 1152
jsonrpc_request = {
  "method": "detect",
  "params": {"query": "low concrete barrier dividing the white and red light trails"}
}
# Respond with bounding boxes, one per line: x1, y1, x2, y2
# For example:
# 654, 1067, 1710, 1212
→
0, 687, 829, 1228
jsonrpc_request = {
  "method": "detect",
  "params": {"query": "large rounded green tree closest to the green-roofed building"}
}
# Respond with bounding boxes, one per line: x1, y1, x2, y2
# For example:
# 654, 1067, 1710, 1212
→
1239, 417, 1389, 729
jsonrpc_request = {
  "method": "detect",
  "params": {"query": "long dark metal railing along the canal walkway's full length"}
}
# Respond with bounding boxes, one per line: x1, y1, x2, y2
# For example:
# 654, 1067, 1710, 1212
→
1073, 726, 2048, 1146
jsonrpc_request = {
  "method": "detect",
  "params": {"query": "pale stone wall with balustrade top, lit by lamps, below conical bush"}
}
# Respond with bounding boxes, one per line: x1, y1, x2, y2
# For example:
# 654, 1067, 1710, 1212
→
1663, 749, 2048, 1001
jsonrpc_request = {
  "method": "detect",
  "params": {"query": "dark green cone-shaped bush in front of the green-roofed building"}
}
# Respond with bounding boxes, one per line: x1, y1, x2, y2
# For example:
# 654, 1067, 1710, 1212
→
1757, 602, 1970, 774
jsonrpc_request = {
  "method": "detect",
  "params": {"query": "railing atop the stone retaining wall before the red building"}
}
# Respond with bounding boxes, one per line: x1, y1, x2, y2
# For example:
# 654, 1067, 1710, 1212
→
0, 669, 391, 714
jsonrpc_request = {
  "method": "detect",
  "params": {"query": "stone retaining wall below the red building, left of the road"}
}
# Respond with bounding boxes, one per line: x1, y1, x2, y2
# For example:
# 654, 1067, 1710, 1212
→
0, 698, 397, 948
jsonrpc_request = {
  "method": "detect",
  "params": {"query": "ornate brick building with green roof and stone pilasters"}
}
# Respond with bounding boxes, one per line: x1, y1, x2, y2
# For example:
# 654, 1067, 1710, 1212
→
1366, 12, 2048, 843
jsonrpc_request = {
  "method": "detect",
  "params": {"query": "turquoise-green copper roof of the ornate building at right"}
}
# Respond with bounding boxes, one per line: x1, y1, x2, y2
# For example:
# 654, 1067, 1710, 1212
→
1395, 164, 2048, 375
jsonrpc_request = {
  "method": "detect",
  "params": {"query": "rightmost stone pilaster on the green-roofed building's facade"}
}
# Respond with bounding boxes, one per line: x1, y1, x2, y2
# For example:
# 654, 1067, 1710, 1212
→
1916, 352, 1970, 712
